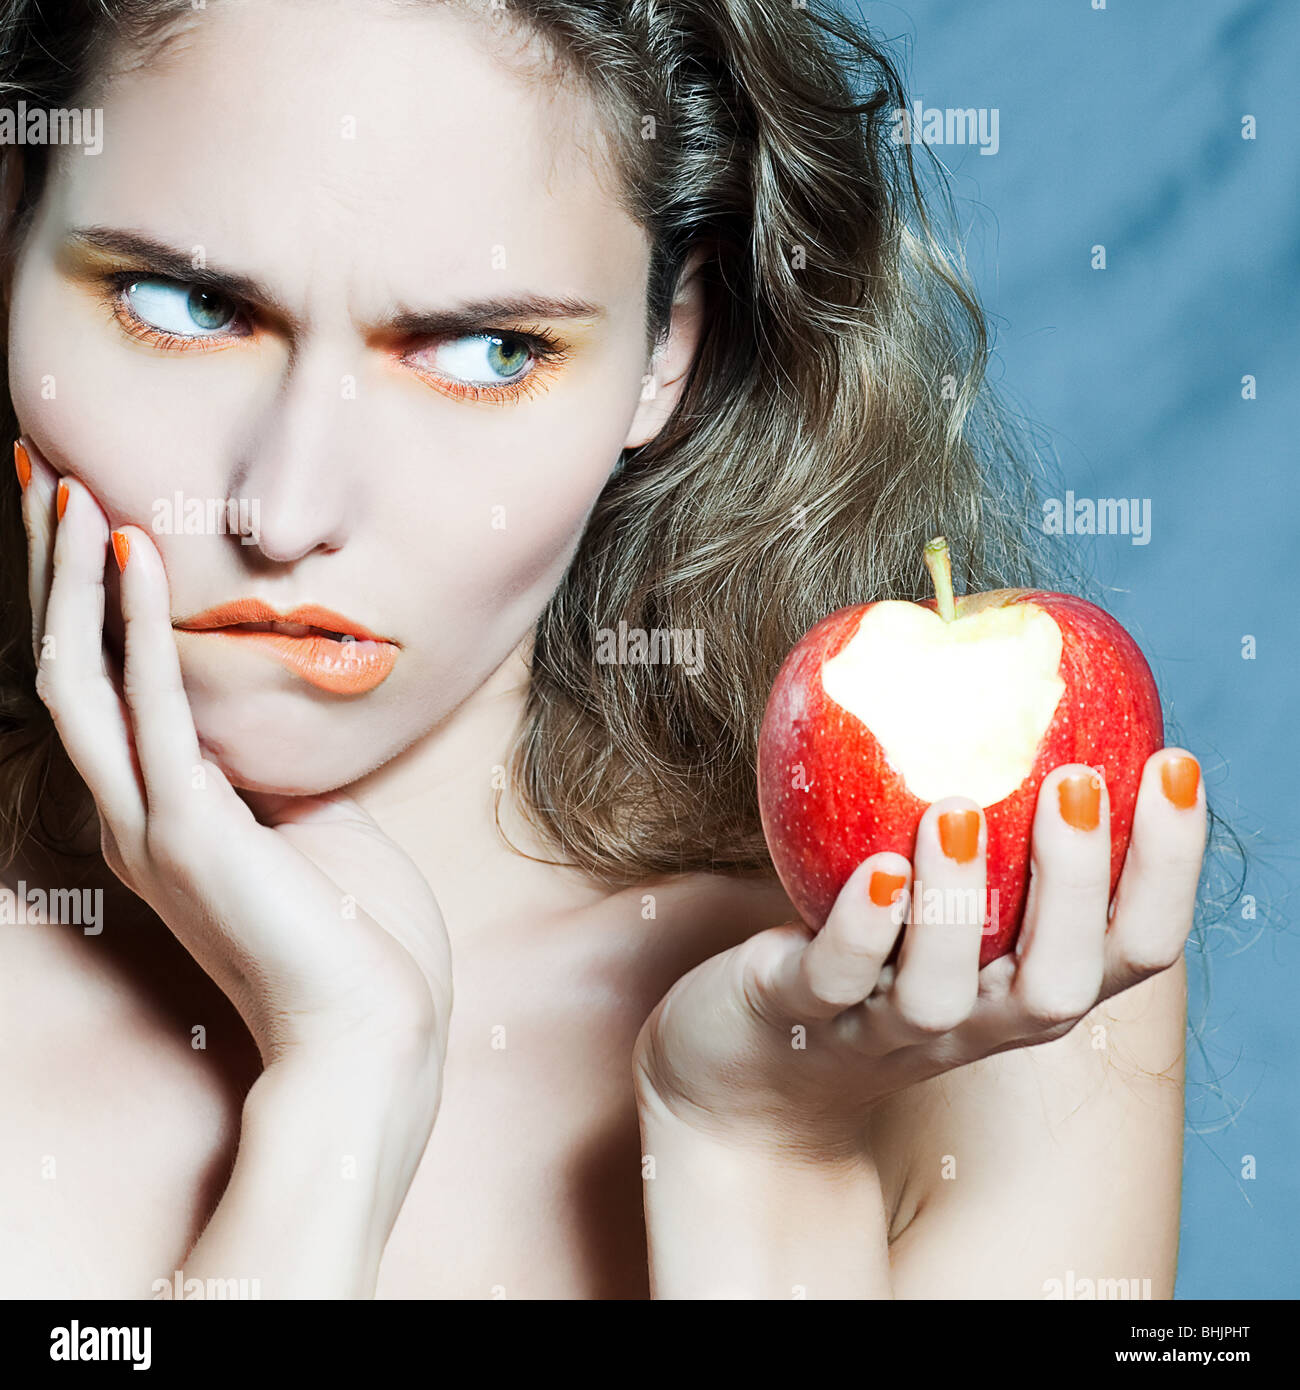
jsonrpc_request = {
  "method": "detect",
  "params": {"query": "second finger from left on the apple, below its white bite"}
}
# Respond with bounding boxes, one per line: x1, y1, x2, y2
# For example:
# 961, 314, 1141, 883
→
865, 796, 987, 1041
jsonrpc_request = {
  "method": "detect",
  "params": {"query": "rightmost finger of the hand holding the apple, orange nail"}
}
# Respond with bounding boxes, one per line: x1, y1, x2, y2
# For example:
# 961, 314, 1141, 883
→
1101, 748, 1205, 998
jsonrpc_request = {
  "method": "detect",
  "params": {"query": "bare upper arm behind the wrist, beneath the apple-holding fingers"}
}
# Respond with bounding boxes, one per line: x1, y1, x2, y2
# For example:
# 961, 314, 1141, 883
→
891, 962, 1186, 1298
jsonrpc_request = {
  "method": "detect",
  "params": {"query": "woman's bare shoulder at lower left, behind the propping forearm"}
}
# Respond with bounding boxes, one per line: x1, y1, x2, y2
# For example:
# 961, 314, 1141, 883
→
0, 866, 246, 1298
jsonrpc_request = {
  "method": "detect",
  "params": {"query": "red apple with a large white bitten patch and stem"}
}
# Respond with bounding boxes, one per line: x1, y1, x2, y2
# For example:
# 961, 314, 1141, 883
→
758, 537, 1164, 966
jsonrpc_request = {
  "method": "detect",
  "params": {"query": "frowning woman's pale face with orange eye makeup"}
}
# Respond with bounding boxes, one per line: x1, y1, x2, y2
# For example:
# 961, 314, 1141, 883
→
10, 3, 681, 792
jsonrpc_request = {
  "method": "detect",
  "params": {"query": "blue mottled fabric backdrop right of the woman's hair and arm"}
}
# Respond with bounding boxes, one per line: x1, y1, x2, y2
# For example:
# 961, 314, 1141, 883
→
841, 0, 1300, 1298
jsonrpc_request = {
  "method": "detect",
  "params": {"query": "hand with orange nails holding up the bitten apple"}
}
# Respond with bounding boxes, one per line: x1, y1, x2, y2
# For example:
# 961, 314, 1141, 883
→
635, 748, 1205, 1170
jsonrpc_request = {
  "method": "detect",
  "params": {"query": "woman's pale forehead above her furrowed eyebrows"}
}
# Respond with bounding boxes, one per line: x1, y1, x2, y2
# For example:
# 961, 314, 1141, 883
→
56, 0, 648, 315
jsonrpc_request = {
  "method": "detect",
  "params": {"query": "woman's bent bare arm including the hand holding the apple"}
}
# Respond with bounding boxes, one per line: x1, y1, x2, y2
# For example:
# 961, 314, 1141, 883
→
635, 749, 1205, 1298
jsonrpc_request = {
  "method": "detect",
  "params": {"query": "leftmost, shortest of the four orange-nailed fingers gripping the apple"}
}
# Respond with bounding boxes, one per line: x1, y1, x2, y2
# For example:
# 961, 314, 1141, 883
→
776, 853, 912, 1019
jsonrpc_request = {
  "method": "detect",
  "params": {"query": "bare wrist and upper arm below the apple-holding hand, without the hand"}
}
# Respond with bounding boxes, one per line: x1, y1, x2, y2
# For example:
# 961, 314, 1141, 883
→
641, 962, 1186, 1298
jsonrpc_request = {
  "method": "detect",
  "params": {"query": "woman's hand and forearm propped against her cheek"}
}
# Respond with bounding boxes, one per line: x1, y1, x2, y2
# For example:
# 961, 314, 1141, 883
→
12, 448, 452, 1297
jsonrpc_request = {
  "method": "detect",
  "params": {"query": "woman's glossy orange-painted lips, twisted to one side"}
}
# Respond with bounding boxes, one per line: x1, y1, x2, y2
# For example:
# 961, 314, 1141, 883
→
172, 599, 400, 695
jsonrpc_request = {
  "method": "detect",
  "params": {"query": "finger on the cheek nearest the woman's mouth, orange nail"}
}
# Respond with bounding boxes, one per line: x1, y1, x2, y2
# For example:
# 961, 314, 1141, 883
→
111, 525, 204, 816
